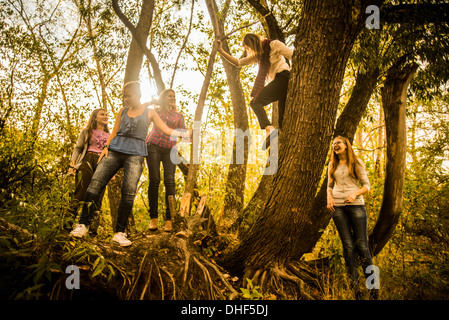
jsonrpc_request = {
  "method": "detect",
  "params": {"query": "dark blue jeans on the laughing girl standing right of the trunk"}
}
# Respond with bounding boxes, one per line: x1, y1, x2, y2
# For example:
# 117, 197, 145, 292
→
332, 205, 373, 280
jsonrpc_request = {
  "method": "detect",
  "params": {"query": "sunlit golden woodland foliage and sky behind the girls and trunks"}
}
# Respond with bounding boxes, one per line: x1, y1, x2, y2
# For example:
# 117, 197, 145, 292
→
0, 0, 449, 299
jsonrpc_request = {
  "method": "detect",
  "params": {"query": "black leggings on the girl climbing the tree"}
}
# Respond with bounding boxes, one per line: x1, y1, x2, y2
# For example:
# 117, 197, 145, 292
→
250, 70, 290, 129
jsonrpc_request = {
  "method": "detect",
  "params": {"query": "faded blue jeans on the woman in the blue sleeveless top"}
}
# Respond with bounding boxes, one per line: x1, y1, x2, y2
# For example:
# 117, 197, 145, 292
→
79, 150, 145, 232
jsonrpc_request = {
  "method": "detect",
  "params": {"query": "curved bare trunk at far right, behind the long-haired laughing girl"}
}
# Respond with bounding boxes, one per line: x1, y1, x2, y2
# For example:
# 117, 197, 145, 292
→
369, 59, 418, 255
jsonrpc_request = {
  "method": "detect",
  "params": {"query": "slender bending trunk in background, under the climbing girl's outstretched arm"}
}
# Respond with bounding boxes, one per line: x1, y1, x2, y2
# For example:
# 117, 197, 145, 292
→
206, 0, 249, 226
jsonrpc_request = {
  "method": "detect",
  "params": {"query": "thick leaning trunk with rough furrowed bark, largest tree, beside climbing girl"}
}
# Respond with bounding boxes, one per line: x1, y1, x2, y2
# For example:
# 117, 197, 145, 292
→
220, 0, 374, 277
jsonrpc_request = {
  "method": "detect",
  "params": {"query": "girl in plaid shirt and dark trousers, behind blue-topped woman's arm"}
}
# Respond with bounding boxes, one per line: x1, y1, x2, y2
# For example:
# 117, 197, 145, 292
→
146, 89, 186, 232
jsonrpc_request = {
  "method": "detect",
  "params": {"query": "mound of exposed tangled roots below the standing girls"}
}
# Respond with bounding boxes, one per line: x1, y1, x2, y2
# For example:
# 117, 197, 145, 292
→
87, 234, 238, 300
